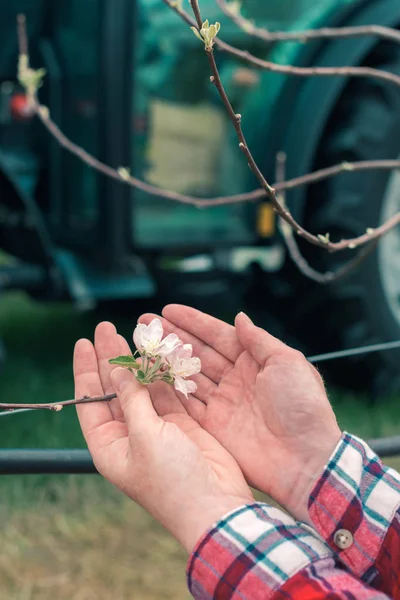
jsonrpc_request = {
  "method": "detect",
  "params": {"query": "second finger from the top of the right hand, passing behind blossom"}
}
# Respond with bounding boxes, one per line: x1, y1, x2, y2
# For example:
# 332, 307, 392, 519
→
139, 314, 233, 383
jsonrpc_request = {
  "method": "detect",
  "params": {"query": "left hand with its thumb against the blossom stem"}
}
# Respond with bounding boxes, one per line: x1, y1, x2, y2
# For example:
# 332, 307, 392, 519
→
74, 323, 254, 552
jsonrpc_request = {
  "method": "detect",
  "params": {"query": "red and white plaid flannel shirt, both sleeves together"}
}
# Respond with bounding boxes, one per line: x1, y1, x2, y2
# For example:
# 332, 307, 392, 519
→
187, 433, 400, 600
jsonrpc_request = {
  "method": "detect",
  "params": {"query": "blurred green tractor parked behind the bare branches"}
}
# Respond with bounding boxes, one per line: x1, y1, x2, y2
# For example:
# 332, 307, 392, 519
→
0, 0, 400, 392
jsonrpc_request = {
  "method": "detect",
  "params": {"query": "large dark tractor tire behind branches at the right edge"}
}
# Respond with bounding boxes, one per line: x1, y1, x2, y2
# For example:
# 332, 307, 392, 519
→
282, 43, 400, 397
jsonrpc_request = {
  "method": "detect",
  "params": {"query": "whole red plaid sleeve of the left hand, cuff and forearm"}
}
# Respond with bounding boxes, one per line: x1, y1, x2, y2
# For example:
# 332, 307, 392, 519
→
187, 503, 388, 600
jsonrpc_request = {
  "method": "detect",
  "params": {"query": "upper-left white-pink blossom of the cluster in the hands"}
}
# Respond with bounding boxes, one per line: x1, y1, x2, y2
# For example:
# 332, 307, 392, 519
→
133, 319, 182, 357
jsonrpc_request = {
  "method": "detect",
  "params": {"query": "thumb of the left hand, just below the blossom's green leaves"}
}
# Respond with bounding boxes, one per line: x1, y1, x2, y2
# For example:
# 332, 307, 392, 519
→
111, 367, 159, 435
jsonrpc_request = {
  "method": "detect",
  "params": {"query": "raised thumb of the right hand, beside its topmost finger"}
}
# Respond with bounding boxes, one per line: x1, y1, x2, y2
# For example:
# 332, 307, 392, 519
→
235, 312, 290, 366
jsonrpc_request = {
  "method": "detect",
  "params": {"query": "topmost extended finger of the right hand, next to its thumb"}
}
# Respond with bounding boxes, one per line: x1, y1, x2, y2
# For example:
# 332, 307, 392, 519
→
162, 304, 243, 362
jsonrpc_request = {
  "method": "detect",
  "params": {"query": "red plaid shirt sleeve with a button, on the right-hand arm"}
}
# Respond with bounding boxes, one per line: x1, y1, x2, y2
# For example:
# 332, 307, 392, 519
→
309, 433, 400, 599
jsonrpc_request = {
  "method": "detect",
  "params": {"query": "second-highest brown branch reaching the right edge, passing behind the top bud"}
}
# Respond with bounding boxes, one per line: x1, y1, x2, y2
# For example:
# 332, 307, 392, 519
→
163, 0, 400, 85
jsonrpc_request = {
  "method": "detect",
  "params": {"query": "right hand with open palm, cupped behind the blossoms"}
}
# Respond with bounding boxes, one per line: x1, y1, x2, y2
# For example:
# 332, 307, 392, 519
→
140, 305, 341, 523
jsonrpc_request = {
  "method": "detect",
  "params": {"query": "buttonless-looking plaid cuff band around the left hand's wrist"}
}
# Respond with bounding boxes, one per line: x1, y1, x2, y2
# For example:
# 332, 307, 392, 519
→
187, 503, 332, 600
